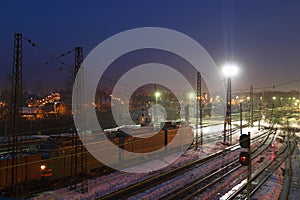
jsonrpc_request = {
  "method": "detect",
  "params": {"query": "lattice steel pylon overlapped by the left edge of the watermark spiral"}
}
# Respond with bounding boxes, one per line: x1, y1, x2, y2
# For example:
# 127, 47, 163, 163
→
70, 47, 88, 193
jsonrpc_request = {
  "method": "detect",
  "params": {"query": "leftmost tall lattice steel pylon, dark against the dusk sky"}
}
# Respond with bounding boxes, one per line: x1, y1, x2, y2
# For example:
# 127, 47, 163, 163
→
6, 33, 23, 197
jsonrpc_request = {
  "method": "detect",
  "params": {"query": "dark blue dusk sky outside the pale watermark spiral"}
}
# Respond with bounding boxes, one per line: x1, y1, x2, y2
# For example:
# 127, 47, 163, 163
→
0, 0, 300, 91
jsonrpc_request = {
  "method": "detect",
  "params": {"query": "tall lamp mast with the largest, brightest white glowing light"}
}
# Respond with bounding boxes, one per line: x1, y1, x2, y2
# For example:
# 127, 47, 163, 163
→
222, 63, 238, 142
